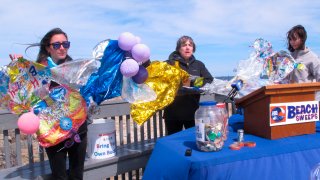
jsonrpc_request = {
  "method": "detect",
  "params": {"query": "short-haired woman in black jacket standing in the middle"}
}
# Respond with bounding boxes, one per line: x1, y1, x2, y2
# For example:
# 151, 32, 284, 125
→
164, 36, 213, 135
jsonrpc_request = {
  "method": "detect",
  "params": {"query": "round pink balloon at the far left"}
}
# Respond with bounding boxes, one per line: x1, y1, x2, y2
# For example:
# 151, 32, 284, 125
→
18, 112, 40, 134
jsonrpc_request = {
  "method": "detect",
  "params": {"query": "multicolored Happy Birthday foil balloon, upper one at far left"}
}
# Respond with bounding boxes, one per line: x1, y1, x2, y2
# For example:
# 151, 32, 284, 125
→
7, 58, 52, 114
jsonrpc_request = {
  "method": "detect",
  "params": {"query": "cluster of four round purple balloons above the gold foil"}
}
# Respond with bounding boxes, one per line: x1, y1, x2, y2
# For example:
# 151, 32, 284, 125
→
118, 32, 150, 84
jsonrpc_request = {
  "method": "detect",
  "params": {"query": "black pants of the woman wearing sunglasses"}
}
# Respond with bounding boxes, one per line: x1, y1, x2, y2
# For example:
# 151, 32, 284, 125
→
46, 132, 88, 180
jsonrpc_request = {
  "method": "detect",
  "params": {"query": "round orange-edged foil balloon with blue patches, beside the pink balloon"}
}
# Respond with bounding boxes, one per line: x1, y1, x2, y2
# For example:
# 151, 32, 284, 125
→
37, 86, 87, 147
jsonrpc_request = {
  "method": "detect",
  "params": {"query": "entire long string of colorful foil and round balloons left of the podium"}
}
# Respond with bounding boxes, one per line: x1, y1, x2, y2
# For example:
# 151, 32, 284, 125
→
0, 32, 188, 138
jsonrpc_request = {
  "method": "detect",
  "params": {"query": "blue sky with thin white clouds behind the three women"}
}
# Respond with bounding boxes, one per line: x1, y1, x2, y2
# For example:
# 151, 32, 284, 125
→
0, 0, 320, 77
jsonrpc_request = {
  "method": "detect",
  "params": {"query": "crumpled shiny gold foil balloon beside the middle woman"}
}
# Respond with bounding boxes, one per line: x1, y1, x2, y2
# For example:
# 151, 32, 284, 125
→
130, 61, 189, 125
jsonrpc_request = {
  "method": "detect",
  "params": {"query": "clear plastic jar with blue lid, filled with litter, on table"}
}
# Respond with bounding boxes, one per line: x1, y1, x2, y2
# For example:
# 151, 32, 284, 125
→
195, 101, 224, 152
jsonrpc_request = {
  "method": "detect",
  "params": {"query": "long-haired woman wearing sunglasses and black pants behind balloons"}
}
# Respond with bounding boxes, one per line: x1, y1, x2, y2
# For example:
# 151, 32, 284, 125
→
33, 28, 87, 179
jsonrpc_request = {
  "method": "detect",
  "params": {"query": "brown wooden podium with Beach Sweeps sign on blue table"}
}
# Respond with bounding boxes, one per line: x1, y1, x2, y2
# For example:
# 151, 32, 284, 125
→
236, 83, 320, 139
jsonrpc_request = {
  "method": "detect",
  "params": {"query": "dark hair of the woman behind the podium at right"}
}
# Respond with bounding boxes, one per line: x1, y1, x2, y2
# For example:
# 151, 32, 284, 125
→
287, 25, 307, 52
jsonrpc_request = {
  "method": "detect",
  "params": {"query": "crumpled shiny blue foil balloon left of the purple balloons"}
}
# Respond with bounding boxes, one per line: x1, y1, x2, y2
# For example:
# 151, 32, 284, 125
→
80, 40, 125, 106
